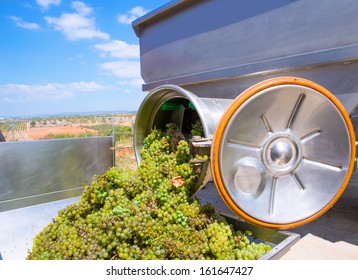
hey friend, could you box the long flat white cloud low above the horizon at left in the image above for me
[0,82,112,102]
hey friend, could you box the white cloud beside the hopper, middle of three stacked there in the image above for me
[94,40,139,59]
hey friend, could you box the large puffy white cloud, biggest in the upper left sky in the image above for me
[45,1,109,40]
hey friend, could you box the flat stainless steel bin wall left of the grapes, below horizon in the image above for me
[0,137,114,212]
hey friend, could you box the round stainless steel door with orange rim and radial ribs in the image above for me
[211,77,355,229]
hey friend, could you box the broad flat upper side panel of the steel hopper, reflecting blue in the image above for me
[134,0,358,89]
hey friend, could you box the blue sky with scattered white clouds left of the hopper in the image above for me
[0,0,169,117]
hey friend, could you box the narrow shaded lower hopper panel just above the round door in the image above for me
[182,60,358,114]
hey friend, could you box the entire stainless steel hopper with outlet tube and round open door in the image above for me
[133,0,358,229]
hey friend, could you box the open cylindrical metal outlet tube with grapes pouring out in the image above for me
[134,85,232,193]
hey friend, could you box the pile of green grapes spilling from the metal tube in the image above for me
[27,123,271,260]
